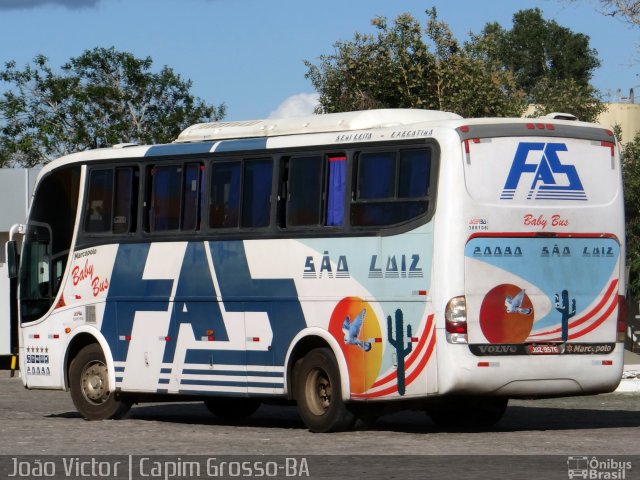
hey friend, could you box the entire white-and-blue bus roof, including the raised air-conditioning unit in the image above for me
[38,109,615,182]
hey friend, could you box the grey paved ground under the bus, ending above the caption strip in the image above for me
[0,374,640,458]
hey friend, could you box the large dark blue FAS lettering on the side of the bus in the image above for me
[101,241,306,379]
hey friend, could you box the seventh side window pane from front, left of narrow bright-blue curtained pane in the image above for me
[287,156,323,227]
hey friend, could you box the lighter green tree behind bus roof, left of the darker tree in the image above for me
[305,9,525,116]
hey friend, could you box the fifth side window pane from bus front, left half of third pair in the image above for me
[209,161,240,228]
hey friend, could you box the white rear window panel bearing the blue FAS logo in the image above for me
[462,136,619,207]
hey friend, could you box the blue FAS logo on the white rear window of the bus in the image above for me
[500,142,587,200]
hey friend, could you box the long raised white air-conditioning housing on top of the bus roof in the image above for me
[174,109,462,143]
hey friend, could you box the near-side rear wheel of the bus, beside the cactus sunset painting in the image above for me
[294,348,355,432]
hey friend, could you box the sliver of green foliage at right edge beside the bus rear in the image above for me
[622,134,640,301]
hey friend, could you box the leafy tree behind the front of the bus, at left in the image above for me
[0,47,225,166]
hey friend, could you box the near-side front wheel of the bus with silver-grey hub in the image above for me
[69,343,131,420]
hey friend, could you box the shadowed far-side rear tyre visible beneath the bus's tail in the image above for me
[427,397,509,429]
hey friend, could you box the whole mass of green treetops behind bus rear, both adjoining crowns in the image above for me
[305,9,602,120]
